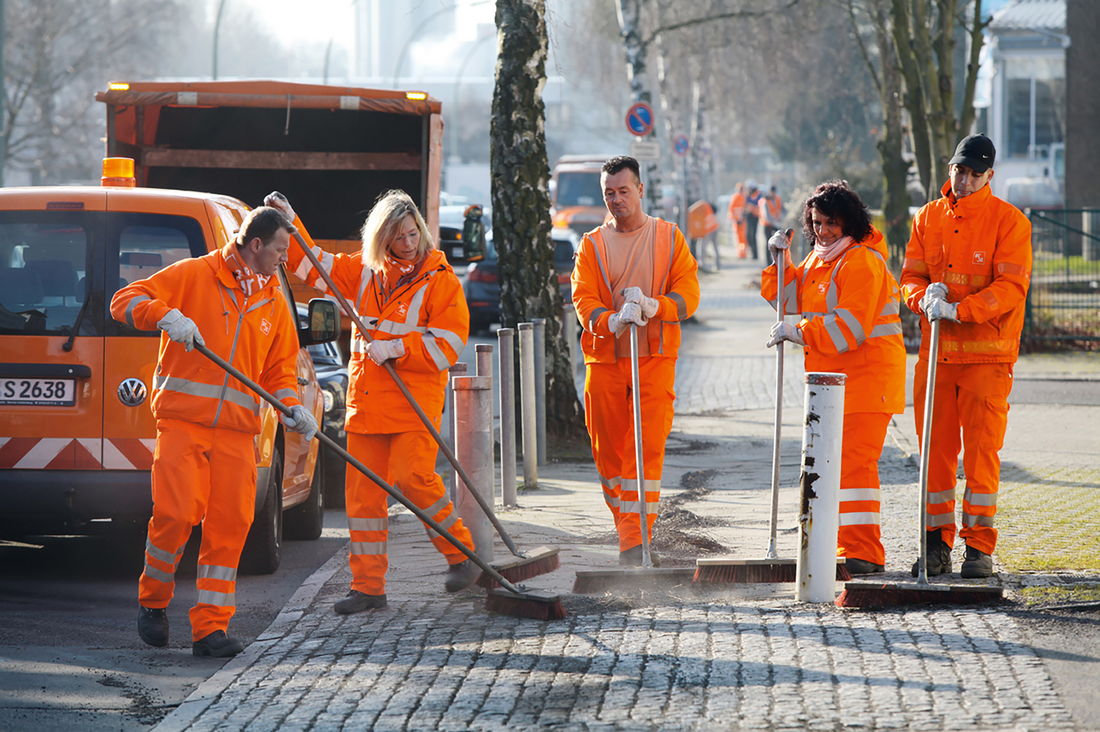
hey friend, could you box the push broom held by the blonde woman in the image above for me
[279,210,561,587]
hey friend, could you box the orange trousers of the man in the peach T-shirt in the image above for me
[584,357,677,551]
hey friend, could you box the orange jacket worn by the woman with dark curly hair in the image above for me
[760,229,905,414]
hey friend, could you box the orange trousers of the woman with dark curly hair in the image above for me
[836,412,890,565]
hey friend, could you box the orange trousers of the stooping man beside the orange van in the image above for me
[138,419,256,641]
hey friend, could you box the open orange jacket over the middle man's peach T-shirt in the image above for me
[573,219,699,363]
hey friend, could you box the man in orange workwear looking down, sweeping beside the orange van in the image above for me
[111,207,317,657]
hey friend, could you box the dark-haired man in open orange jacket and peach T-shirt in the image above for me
[573,155,699,565]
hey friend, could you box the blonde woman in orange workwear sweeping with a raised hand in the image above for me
[265,190,481,615]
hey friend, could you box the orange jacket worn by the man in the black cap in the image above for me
[901,183,1032,363]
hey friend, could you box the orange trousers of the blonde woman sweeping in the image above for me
[344,429,474,594]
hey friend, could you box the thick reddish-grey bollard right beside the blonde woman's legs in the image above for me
[452,376,493,561]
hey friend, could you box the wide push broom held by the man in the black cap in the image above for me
[836,319,1003,608]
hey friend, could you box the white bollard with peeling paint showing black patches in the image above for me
[795,373,847,602]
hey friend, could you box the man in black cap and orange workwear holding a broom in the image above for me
[901,134,1032,577]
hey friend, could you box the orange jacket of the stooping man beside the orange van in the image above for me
[111,243,299,434]
